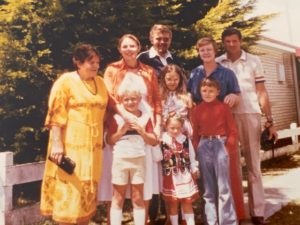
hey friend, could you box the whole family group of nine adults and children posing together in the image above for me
[41,24,277,225]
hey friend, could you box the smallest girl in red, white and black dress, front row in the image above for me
[161,113,199,225]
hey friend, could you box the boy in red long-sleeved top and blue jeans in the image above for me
[192,78,237,225]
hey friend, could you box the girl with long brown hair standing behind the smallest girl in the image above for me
[160,64,192,137]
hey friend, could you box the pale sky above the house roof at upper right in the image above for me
[254,0,300,47]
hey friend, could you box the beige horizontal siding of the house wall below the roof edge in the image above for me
[257,45,298,130]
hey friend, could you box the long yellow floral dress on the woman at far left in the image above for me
[41,72,108,223]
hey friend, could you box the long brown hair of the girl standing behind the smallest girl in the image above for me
[159,64,186,100]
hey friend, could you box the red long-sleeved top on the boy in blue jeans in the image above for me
[191,99,238,151]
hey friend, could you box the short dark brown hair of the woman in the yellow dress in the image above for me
[72,44,100,68]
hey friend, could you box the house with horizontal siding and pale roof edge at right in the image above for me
[256,37,300,130]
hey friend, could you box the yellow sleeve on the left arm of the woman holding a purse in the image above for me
[45,75,70,128]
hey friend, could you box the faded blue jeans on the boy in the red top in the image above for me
[197,138,237,225]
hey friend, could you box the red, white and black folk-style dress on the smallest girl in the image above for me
[161,133,199,202]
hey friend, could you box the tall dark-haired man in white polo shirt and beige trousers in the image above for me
[216,28,277,225]
